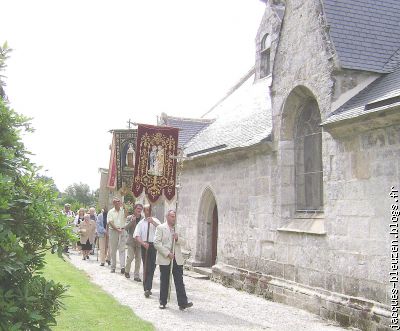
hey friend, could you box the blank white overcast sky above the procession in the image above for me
[0,0,265,190]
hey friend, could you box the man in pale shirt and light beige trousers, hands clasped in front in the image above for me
[107,197,126,274]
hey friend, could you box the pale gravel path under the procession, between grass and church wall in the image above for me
[65,252,356,331]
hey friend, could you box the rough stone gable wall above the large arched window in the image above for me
[271,0,336,124]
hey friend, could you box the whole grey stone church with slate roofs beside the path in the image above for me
[159,0,400,330]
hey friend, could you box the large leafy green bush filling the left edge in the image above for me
[0,46,73,331]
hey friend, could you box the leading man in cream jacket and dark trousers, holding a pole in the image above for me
[154,210,193,310]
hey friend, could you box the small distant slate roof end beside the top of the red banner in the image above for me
[159,113,213,146]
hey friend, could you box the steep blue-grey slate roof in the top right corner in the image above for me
[323,0,400,73]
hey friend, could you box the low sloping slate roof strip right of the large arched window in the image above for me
[322,66,400,124]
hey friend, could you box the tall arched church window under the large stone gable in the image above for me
[294,101,323,212]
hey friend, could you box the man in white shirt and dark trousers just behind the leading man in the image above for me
[133,205,161,298]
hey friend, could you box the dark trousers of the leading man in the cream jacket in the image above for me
[160,259,187,306]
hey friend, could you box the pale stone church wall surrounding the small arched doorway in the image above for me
[179,143,273,269]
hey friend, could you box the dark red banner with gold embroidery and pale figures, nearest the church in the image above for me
[132,124,179,202]
